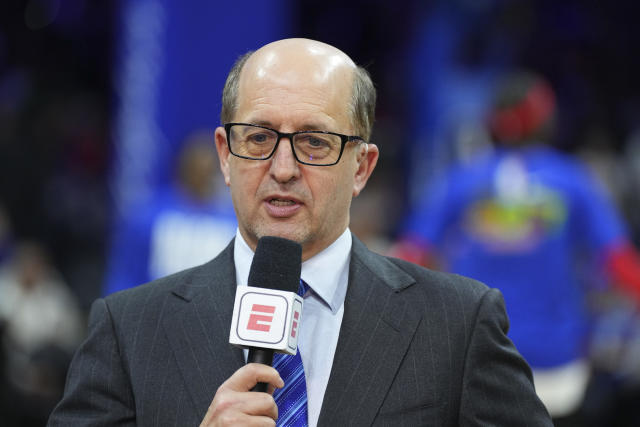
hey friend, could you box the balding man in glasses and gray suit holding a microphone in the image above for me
[50,39,550,426]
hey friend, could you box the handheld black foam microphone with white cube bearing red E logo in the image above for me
[229,236,303,391]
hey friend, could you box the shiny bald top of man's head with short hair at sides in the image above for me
[220,39,376,140]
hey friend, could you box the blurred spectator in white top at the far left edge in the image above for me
[0,242,84,426]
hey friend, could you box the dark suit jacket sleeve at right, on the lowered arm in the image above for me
[459,289,553,427]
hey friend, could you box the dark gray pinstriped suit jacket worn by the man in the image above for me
[49,236,552,426]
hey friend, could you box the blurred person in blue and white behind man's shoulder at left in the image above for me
[105,132,236,294]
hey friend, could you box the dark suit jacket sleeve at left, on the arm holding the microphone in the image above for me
[47,299,136,427]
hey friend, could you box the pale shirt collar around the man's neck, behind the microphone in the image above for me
[233,228,352,313]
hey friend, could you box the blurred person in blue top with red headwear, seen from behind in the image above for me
[393,72,640,425]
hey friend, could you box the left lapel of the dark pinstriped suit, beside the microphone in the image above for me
[163,241,244,415]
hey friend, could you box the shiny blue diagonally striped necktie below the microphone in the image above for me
[273,280,309,427]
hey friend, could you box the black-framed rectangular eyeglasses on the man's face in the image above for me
[224,123,365,166]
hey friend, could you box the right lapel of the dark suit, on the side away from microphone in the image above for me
[318,236,421,425]
